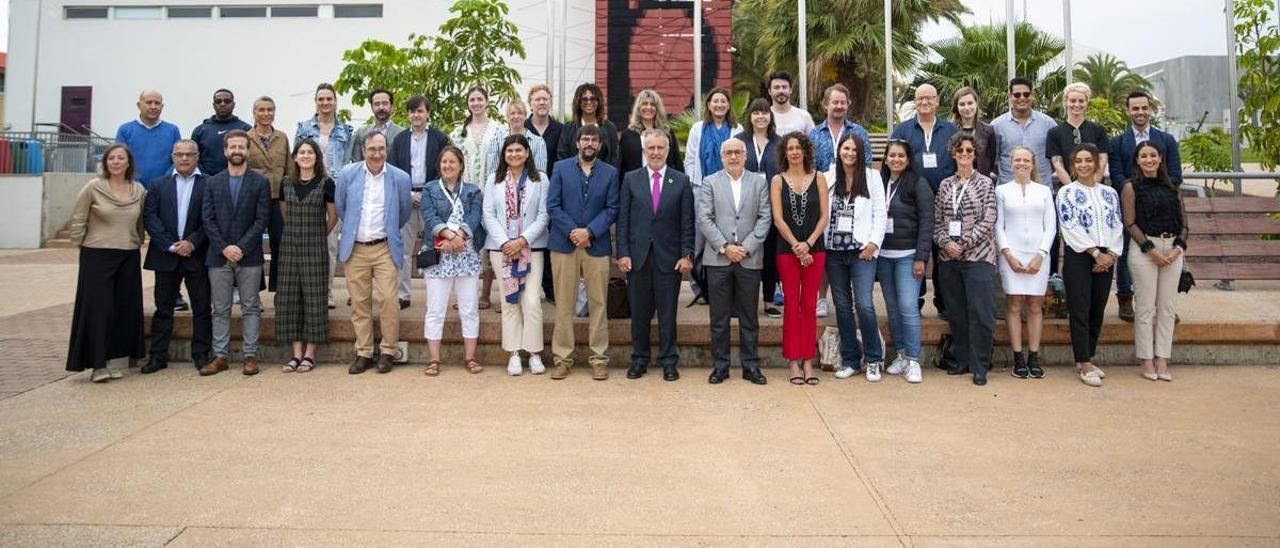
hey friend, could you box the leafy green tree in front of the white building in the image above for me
[334,0,525,127]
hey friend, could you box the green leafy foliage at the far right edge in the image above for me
[1235,0,1280,175]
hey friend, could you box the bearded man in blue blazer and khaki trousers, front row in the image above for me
[547,125,618,380]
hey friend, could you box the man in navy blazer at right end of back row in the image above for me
[1107,91,1183,321]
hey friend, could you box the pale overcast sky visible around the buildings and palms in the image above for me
[0,0,1259,67]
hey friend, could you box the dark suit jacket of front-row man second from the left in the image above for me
[142,173,209,273]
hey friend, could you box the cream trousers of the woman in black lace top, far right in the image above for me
[1129,236,1183,360]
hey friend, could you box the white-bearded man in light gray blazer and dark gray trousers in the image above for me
[698,138,773,384]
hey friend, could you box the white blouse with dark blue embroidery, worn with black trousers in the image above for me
[1057,181,1124,255]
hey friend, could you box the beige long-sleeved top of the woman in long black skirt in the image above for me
[68,178,147,250]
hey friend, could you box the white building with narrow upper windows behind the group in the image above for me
[4,0,595,138]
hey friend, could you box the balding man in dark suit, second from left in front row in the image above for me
[142,140,212,374]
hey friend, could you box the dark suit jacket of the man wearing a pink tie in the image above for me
[618,165,694,273]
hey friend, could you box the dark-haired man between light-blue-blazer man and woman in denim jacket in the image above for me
[386,95,449,310]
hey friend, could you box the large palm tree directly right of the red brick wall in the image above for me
[733,0,968,120]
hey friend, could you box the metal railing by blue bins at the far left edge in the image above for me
[0,131,115,173]
